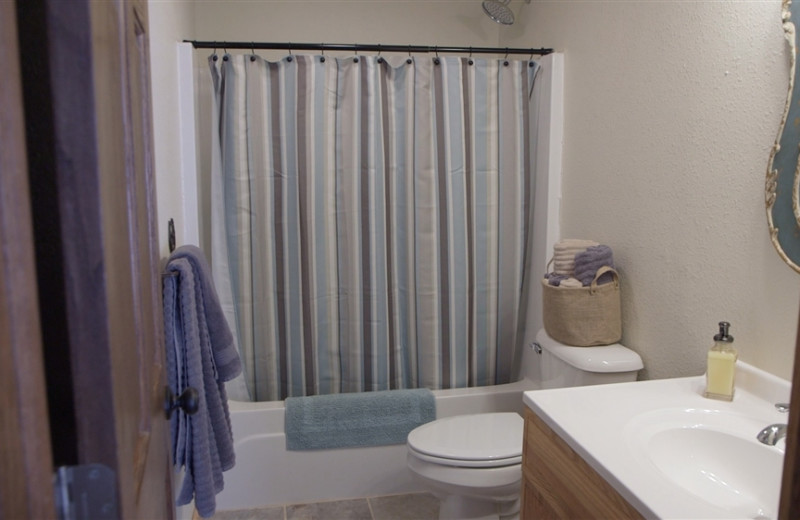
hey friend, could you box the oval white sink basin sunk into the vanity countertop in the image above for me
[625,409,785,519]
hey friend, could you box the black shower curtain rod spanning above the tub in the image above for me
[184,40,553,56]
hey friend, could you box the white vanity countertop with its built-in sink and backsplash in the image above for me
[524,362,791,519]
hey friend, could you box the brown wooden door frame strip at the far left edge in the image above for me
[0,2,55,519]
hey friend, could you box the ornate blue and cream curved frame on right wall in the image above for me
[765,0,800,273]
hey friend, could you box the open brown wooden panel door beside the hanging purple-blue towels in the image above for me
[17,0,174,519]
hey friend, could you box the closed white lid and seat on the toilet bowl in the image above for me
[408,413,524,466]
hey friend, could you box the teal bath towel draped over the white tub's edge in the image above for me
[285,388,436,450]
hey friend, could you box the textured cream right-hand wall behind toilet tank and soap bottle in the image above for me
[500,0,800,379]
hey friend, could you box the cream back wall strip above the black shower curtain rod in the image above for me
[191,0,499,58]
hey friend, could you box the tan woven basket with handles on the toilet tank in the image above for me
[542,266,622,347]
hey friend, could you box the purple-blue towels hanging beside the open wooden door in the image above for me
[164,246,242,518]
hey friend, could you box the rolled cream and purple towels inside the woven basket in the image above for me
[545,238,614,287]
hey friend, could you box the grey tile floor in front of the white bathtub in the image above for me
[206,493,439,520]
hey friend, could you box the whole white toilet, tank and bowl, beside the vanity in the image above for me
[406,330,644,520]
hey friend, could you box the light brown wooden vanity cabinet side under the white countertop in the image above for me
[521,408,644,520]
